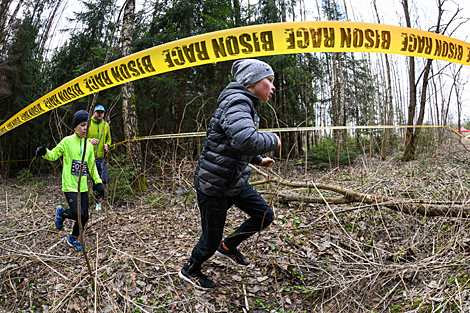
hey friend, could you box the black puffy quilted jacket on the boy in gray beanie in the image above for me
[194,82,278,197]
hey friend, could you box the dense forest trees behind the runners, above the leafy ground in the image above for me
[0,0,468,177]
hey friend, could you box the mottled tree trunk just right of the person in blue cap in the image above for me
[122,0,147,191]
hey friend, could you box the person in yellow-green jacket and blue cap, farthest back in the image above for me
[88,104,111,211]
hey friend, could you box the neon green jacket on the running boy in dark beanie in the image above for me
[43,134,102,192]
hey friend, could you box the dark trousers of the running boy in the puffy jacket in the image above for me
[190,184,274,269]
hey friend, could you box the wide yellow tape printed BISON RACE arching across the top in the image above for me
[0,21,470,136]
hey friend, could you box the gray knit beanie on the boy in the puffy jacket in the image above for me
[232,59,274,87]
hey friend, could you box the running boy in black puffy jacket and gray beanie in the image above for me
[179,59,281,289]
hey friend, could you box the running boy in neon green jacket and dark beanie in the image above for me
[36,110,104,250]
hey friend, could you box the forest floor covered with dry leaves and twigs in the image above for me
[0,135,470,313]
